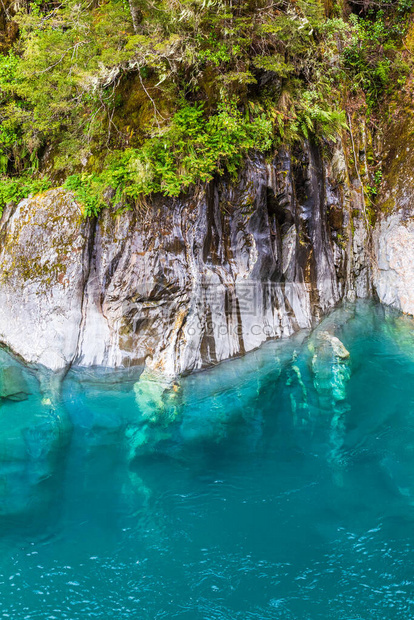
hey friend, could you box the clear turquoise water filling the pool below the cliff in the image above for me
[0,304,414,620]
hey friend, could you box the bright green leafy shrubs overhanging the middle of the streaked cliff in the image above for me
[65,102,272,215]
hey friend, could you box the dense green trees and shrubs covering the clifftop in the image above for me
[0,0,414,214]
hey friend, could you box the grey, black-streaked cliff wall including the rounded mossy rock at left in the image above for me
[0,145,371,376]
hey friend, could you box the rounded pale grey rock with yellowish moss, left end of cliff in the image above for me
[0,190,90,370]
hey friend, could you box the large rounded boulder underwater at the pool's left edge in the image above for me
[0,355,71,517]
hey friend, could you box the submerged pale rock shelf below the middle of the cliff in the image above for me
[125,332,306,460]
